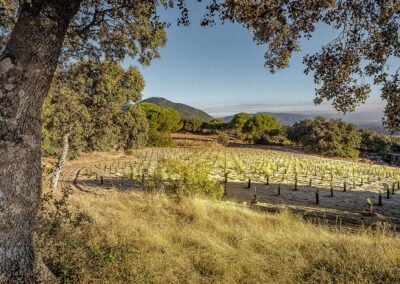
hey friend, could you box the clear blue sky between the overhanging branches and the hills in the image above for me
[125,1,383,117]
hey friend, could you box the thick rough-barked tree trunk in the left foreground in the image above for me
[0,0,80,283]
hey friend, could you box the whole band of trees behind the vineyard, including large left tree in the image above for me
[42,60,400,173]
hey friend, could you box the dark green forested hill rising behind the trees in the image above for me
[142,97,213,121]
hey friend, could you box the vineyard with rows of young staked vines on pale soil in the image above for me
[50,148,400,229]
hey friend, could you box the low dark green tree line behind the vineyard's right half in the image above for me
[182,112,400,160]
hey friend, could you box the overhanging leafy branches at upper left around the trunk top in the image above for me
[0,0,167,65]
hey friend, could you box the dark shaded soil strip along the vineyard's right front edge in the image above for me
[226,182,400,230]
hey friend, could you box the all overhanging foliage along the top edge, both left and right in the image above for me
[0,0,400,130]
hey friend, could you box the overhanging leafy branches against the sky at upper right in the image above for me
[203,0,400,130]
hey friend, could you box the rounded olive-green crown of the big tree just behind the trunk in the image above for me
[42,61,148,154]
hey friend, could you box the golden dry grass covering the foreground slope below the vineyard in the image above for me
[42,187,400,283]
